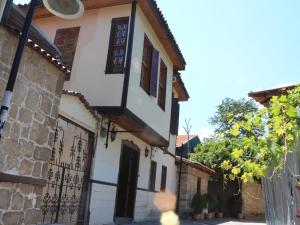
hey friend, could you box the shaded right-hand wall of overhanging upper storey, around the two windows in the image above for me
[127,7,173,140]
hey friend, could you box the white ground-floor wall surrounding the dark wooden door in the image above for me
[90,124,177,225]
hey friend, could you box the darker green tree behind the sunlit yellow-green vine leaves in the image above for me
[190,98,258,175]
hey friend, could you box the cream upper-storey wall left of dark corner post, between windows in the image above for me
[35,4,131,106]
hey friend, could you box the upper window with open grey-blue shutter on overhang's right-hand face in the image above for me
[140,35,159,97]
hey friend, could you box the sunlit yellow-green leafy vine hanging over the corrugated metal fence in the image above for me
[219,86,300,182]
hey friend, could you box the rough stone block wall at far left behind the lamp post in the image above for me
[0,26,64,225]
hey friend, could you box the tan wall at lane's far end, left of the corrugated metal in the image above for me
[242,183,265,217]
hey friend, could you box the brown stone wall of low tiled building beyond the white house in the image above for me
[178,164,209,214]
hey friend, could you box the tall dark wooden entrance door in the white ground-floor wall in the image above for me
[115,145,140,222]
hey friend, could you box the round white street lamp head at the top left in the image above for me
[43,0,84,19]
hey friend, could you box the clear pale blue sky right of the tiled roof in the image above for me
[15,0,300,136]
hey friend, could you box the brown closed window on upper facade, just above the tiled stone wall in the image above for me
[54,27,80,80]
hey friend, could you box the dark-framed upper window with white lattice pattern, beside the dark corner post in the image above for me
[105,17,129,74]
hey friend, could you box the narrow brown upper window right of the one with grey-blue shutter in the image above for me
[158,60,168,110]
